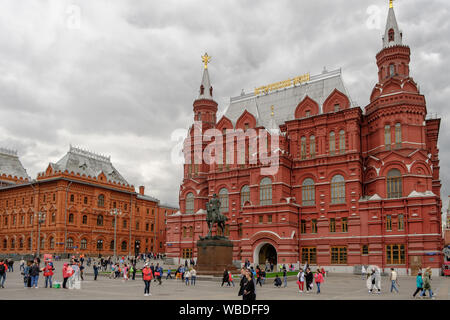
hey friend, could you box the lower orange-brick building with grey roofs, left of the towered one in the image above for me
[0,146,178,256]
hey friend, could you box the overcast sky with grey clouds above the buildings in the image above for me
[0,0,450,212]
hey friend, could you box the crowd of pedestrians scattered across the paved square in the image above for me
[0,254,435,300]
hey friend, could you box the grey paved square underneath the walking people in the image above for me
[0,262,450,300]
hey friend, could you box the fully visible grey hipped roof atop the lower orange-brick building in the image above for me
[50,146,129,185]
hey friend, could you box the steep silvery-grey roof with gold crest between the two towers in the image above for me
[225,69,354,129]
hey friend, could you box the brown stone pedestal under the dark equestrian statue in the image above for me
[196,237,239,276]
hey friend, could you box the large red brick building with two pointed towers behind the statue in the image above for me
[166,4,443,274]
